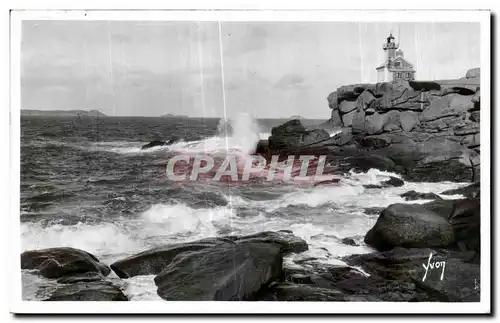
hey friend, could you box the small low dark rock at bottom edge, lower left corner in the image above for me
[46,281,128,301]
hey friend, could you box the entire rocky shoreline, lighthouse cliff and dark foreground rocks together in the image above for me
[21,69,481,302]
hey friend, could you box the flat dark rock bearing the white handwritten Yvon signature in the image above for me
[344,248,480,302]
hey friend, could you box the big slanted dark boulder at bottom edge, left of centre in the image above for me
[154,242,283,301]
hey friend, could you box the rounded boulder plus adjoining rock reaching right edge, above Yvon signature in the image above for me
[365,190,481,259]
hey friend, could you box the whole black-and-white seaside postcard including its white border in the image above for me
[10,6,491,313]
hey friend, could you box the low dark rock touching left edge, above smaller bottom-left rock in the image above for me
[21,247,110,278]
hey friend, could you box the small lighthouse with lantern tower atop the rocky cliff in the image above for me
[376,34,416,82]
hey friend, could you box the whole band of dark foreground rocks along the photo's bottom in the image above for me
[21,184,480,302]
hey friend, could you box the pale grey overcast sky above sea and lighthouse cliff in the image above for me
[21,21,480,119]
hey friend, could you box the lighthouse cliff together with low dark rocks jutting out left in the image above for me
[246,69,480,182]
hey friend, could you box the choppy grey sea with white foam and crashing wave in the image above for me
[20,114,466,301]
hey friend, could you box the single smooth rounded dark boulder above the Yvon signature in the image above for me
[365,204,455,250]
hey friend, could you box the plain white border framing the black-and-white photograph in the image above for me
[8,8,491,314]
